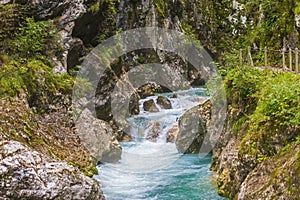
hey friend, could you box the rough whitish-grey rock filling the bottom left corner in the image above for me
[0,141,105,200]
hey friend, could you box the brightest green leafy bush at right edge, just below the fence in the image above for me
[251,72,300,128]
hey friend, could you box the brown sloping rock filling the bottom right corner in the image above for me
[237,144,300,200]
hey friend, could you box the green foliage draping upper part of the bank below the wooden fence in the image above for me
[225,67,300,163]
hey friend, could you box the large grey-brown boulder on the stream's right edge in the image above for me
[175,101,211,153]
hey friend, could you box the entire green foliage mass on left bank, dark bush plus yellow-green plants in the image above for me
[0,14,74,109]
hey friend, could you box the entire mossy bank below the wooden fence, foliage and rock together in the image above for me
[211,67,300,199]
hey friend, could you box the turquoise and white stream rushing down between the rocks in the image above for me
[95,89,227,200]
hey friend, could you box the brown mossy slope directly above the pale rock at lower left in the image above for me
[0,95,96,176]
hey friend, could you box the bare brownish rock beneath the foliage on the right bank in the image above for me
[211,110,300,200]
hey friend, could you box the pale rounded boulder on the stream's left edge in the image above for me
[76,109,122,163]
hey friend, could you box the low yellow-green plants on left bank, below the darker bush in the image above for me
[0,59,74,98]
